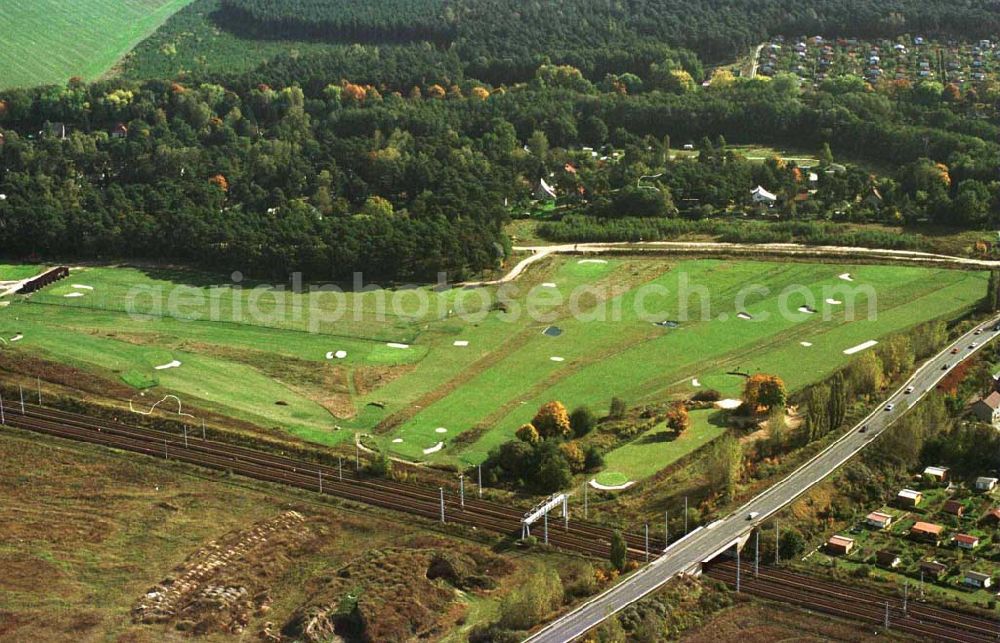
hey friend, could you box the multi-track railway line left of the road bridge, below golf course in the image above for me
[4,404,664,561]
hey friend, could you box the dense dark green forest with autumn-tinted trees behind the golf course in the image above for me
[0,0,1000,280]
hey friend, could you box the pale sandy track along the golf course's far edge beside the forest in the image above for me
[488,241,1000,286]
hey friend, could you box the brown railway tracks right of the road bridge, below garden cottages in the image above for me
[705,560,1000,643]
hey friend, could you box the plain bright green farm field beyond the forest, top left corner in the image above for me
[0,0,191,89]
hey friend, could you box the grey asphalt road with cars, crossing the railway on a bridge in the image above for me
[526,317,1000,643]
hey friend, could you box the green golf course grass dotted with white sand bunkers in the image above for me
[0,257,986,468]
